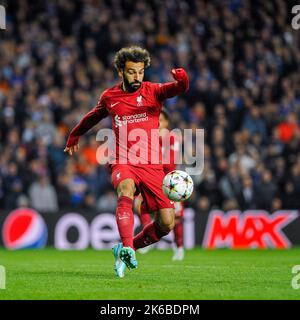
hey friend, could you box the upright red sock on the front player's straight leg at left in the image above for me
[116,196,134,248]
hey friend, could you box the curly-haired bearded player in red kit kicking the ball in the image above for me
[64,46,189,277]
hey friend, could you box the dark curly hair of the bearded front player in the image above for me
[114,46,150,70]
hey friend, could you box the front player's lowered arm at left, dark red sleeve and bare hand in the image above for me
[64,103,108,156]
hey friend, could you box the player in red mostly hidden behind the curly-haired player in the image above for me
[137,108,184,261]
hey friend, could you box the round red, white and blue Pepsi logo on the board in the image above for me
[2,208,48,249]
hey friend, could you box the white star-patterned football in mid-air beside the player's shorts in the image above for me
[162,170,194,202]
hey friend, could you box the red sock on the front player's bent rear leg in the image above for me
[133,221,169,250]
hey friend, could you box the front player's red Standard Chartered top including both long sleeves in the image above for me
[67,75,189,166]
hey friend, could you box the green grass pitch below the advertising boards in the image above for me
[0,248,300,300]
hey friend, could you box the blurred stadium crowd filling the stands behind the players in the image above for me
[0,0,300,212]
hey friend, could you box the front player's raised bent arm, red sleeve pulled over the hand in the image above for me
[157,68,189,100]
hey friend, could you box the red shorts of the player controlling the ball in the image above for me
[111,164,174,212]
